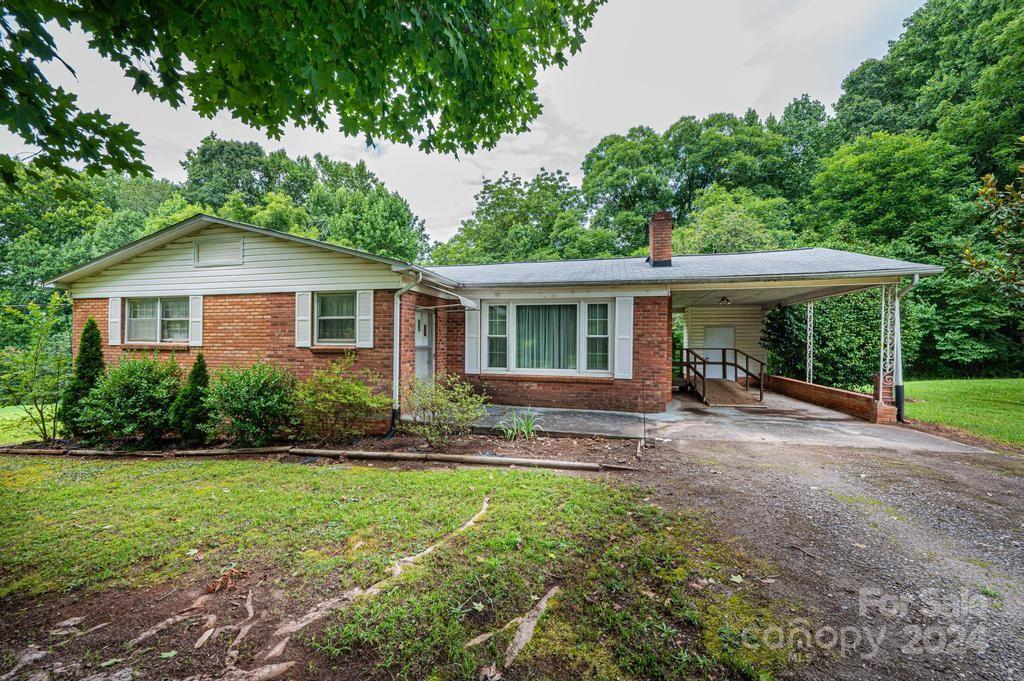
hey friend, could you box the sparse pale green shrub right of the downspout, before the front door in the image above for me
[406,374,487,450]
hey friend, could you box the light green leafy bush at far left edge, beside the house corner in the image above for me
[0,293,71,441]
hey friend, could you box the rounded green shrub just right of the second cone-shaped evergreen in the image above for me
[206,364,295,446]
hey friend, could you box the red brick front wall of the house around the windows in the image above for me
[73,291,672,412]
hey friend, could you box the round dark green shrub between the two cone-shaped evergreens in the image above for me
[79,356,181,449]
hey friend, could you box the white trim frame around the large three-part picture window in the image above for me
[480,298,615,378]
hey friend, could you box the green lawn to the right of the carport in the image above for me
[906,378,1024,445]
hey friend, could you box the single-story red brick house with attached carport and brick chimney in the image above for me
[47,212,942,420]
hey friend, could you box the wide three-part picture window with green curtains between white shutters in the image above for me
[480,300,613,375]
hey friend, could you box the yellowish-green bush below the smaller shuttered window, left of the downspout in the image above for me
[296,354,391,442]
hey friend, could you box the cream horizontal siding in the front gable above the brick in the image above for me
[71,226,401,298]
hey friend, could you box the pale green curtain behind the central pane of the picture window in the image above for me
[515,305,577,369]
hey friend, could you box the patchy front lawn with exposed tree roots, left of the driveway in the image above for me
[0,457,792,679]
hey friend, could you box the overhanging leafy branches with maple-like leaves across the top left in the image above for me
[0,0,604,182]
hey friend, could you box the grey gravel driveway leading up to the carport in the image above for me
[632,396,1024,679]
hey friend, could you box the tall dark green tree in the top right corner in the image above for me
[836,0,1024,181]
